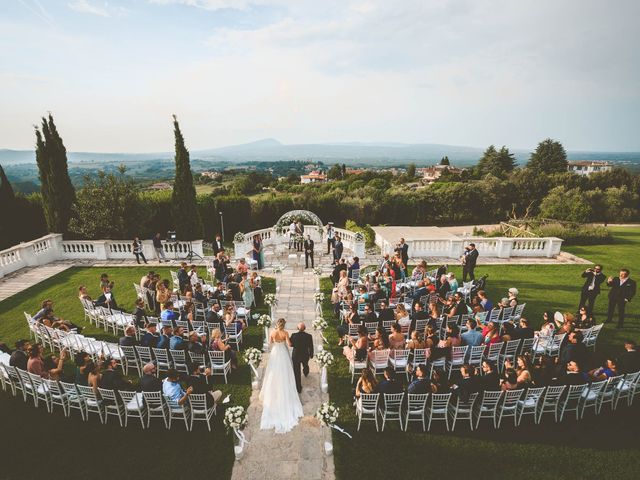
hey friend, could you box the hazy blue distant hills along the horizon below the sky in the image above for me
[0,138,640,167]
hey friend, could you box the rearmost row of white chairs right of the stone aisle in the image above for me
[356,372,640,431]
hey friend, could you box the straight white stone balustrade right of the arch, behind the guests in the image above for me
[376,235,562,258]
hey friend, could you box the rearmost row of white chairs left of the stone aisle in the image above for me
[0,363,216,431]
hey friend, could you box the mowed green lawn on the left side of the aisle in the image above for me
[0,267,275,479]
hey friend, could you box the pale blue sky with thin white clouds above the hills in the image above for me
[0,0,640,152]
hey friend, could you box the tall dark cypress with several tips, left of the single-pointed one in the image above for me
[36,114,75,233]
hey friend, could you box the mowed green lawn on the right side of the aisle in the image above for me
[321,228,640,479]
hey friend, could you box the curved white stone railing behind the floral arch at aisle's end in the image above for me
[233,225,365,258]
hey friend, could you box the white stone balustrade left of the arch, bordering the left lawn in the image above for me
[0,233,203,277]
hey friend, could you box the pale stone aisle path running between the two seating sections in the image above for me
[232,267,335,480]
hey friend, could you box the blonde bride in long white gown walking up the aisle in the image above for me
[260,318,303,433]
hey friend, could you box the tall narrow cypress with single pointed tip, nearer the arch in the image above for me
[171,115,204,240]
